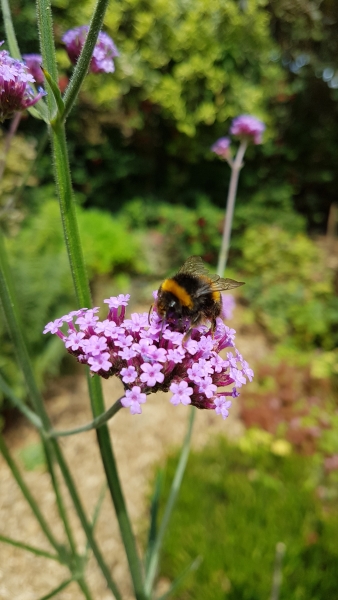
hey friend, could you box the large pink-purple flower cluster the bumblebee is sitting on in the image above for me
[44,294,253,419]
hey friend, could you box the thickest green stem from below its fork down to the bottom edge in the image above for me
[51,122,145,600]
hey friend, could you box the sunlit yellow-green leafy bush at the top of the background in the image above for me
[57,0,282,135]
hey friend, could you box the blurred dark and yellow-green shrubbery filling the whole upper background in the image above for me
[1,0,338,231]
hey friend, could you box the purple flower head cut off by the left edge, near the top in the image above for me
[0,42,46,121]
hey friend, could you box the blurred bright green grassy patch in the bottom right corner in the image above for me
[160,432,338,600]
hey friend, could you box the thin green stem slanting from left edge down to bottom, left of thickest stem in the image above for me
[0,235,121,600]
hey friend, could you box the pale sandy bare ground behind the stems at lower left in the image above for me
[0,309,268,600]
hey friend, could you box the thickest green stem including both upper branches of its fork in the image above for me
[37,0,145,600]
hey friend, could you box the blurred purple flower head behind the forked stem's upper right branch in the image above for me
[62,25,119,73]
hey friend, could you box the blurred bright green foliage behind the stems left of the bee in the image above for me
[0,200,146,404]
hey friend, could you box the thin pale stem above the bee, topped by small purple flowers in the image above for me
[217,140,248,277]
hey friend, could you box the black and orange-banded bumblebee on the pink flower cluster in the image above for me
[149,256,244,341]
